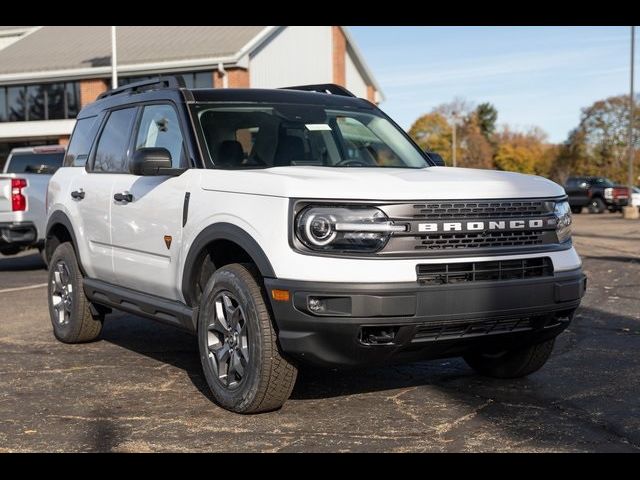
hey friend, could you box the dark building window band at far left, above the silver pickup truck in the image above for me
[0,82,80,122]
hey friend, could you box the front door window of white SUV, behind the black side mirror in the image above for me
[136,105,188,168]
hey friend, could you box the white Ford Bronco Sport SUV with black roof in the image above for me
[46,78,586,413]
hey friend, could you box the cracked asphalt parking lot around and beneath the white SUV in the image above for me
[0,214,640,452]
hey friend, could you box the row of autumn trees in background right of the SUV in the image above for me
[409,95,640,183]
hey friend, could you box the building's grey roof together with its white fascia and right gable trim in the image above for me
[0,26,383,98]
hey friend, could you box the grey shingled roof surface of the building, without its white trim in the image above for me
[0,26,266,75]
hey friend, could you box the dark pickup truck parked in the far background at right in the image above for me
[564,177,629,213]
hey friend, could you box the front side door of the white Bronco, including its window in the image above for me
[111,103,189,300]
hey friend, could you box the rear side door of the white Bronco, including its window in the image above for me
[69,107,138,283]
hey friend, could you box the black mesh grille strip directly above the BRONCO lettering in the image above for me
[413,200,554,220]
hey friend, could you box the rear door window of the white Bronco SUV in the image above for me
[93,108,137,173]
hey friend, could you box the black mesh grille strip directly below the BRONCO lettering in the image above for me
[414,230,544,250]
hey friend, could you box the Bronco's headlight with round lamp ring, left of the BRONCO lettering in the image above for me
[295,206,407,252]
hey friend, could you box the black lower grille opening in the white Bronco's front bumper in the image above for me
[416,257,553,285]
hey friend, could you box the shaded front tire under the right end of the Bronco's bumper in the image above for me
[464,338,555,378]
